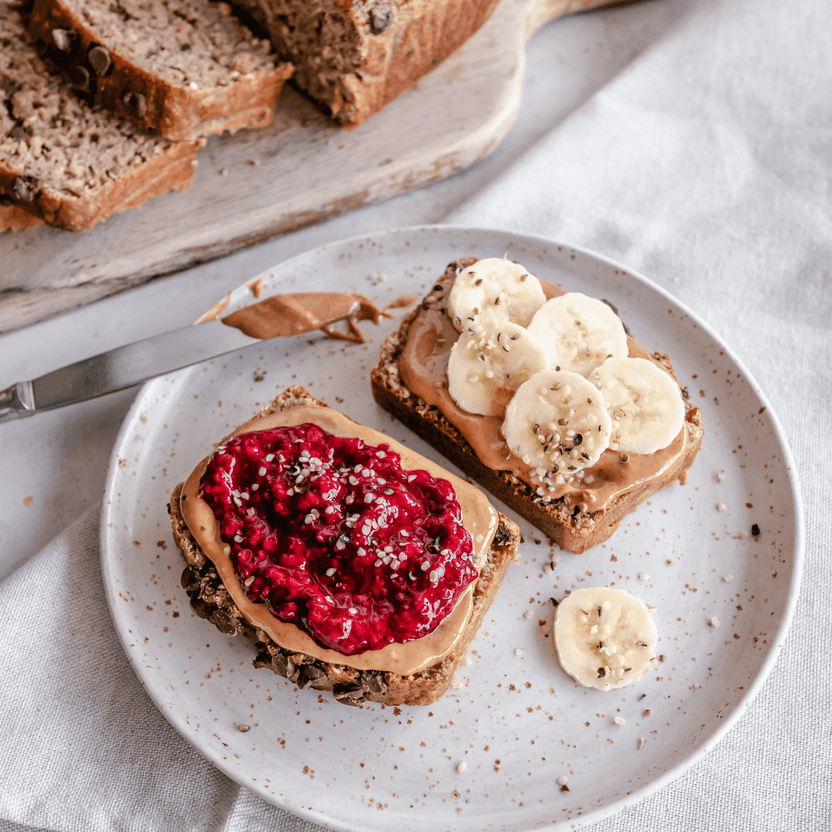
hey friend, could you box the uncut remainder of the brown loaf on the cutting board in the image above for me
[221,0,497,127]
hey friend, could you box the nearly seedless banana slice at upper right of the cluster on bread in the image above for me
[529,292,628,376]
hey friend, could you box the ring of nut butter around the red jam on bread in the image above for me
[181,405,498,676]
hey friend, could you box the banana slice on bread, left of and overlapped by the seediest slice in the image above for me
[448,321,552,418]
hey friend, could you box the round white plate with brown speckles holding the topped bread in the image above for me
[101,227,802,832]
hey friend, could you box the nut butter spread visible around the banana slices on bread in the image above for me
[399,281,688,512]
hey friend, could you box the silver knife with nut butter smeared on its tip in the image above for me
[0,292,381,422]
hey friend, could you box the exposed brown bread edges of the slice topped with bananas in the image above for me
[371,257,702,553]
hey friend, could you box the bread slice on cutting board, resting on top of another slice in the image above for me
[28,0,292,141]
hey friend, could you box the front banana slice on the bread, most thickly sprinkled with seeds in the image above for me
[503,370,612,480]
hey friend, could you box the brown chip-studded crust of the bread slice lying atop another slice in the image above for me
[28,0,293,141]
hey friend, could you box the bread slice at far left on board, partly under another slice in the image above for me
[0,3,200,231]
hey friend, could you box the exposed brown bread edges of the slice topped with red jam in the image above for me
[169,386,520,705]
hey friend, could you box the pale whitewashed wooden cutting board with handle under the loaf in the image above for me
[0,0,636,332]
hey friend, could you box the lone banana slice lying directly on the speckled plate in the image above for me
[552,587,658,690]
